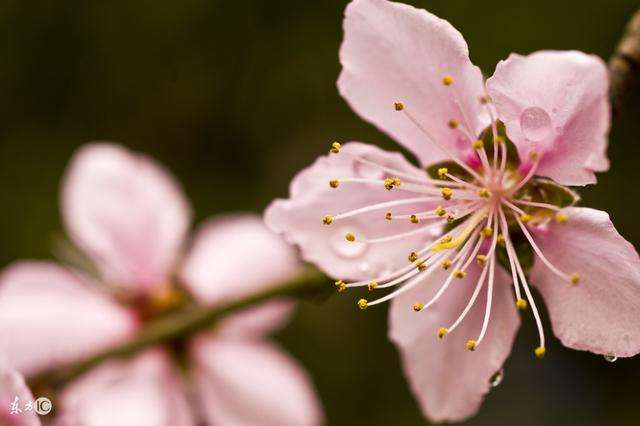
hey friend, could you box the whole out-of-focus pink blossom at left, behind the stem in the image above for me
[0,144,321,425]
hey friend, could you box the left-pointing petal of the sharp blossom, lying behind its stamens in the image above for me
[265,142,435,279]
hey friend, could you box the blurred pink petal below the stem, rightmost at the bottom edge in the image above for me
[193,338,322,426]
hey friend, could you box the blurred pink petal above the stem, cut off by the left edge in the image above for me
[0,262,137,375]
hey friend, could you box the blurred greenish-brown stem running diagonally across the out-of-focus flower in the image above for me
[30,268,329,387]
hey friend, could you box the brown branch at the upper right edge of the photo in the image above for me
[609,10,640,115]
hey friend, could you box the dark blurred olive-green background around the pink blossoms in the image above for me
[0,0,640,425]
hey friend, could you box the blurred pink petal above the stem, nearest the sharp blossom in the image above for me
[182,214,301,304]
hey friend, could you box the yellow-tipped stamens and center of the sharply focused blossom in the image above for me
[322,76,579,357]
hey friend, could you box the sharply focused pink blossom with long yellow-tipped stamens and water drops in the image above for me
[265,0,640,421]
